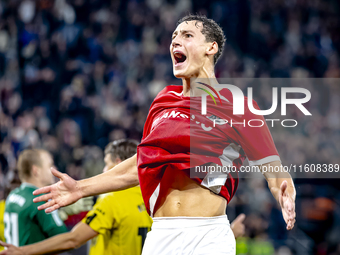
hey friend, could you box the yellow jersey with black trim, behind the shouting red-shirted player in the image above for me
[83,187,152,255]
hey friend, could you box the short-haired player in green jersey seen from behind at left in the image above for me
[4,149,67,246]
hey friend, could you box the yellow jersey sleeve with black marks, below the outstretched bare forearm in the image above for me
[82,194,114,234]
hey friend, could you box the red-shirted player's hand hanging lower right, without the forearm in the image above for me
[279,181,296,230]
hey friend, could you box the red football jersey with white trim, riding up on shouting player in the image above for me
[137,85,280,216]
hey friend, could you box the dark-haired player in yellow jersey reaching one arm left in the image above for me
[0,139,152,255]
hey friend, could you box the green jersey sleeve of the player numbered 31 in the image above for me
[31,203,67,237]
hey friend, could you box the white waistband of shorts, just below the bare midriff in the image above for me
[152,215,230,229]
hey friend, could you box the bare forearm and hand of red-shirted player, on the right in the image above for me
[259,161,296,230]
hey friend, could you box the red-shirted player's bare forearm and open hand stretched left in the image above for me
[33,154,139,213]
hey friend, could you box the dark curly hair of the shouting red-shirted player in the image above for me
[177,14,226,64]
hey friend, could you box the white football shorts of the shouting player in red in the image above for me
[142,215,236,255]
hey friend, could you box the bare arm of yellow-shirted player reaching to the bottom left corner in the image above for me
[0,222,98,255]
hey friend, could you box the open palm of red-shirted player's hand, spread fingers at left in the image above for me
[33,168,82,213]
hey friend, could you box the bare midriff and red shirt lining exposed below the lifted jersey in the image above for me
[154,167,227,217]
